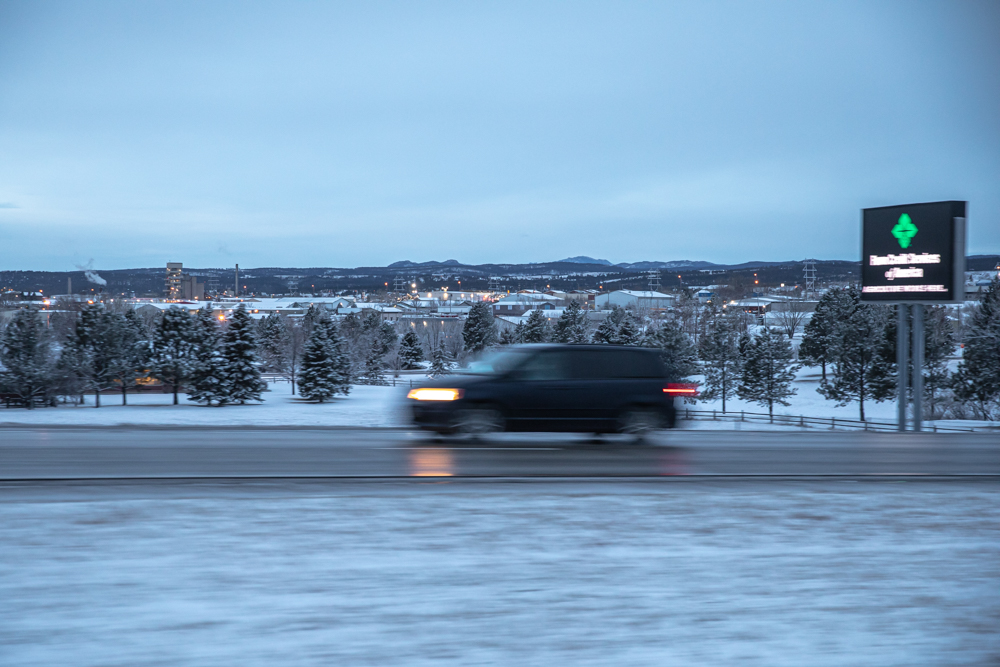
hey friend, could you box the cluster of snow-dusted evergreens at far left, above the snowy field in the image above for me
[0,304,266,407]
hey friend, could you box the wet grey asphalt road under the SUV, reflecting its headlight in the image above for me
[0,428,1000,481]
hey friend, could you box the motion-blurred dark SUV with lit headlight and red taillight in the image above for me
[407,345,693,435]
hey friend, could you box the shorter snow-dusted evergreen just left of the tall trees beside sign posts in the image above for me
[736,327,796,417]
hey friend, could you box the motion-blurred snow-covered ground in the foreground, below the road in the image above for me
[0,481,1000,667]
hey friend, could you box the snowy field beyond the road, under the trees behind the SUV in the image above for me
[0,369,990,430]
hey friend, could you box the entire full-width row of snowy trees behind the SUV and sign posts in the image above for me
[0,281,1000,419]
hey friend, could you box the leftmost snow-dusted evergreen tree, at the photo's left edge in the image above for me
[0,308,56,408]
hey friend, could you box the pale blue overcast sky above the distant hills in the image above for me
[0,0,1000,271]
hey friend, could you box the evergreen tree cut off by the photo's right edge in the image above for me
[953,278,1000,419]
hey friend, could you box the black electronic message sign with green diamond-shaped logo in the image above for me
[861,201,966,303]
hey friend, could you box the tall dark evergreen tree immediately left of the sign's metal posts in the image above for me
[818,287,896,421]
